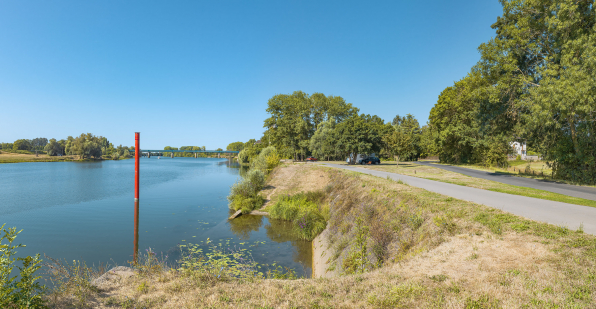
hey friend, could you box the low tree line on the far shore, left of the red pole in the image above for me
[0,133,134,159]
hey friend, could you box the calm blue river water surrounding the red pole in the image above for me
[0,157,312,276]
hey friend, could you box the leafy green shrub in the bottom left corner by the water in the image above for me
[0,224,45,308]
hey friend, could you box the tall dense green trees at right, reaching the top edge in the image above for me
[429,0,596,184]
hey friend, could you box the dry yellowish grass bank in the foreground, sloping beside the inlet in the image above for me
[48,164,596,308]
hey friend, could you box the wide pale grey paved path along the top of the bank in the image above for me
[322,163,596,235]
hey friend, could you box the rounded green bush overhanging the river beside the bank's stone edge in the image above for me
[228,169,265,213]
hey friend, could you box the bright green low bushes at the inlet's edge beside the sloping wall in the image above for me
[268,191,329,241]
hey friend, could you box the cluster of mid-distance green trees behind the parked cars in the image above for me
[226,91,436,162]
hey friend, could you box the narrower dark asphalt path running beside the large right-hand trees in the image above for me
[414,161,596,201]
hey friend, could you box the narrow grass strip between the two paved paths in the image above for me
[330,161,596,207]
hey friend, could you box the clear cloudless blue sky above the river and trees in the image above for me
[0,0,502,149]
